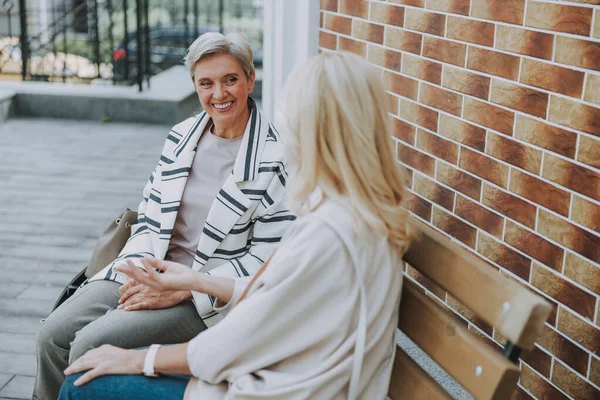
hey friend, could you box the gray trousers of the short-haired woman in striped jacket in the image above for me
[33,281,206,400]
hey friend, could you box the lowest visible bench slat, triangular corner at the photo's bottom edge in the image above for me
[388,347,452,400]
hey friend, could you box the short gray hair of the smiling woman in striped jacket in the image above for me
[183,32,255,79]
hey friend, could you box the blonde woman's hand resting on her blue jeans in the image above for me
[65,344,147,386]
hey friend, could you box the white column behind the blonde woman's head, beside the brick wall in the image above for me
[262,0,320,121]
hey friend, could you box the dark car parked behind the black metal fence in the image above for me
[113,27,263,85]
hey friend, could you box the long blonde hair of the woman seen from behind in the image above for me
[279,52,412,251]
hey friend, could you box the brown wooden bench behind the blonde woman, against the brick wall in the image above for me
[389,222,551,400]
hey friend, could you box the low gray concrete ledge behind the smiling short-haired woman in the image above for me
[0,66,262,125]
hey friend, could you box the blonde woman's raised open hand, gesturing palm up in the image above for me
[115,258,197,292]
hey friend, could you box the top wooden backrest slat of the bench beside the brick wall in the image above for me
[404,221,551,350]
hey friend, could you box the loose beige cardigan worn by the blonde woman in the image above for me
[187,192,402,400]
